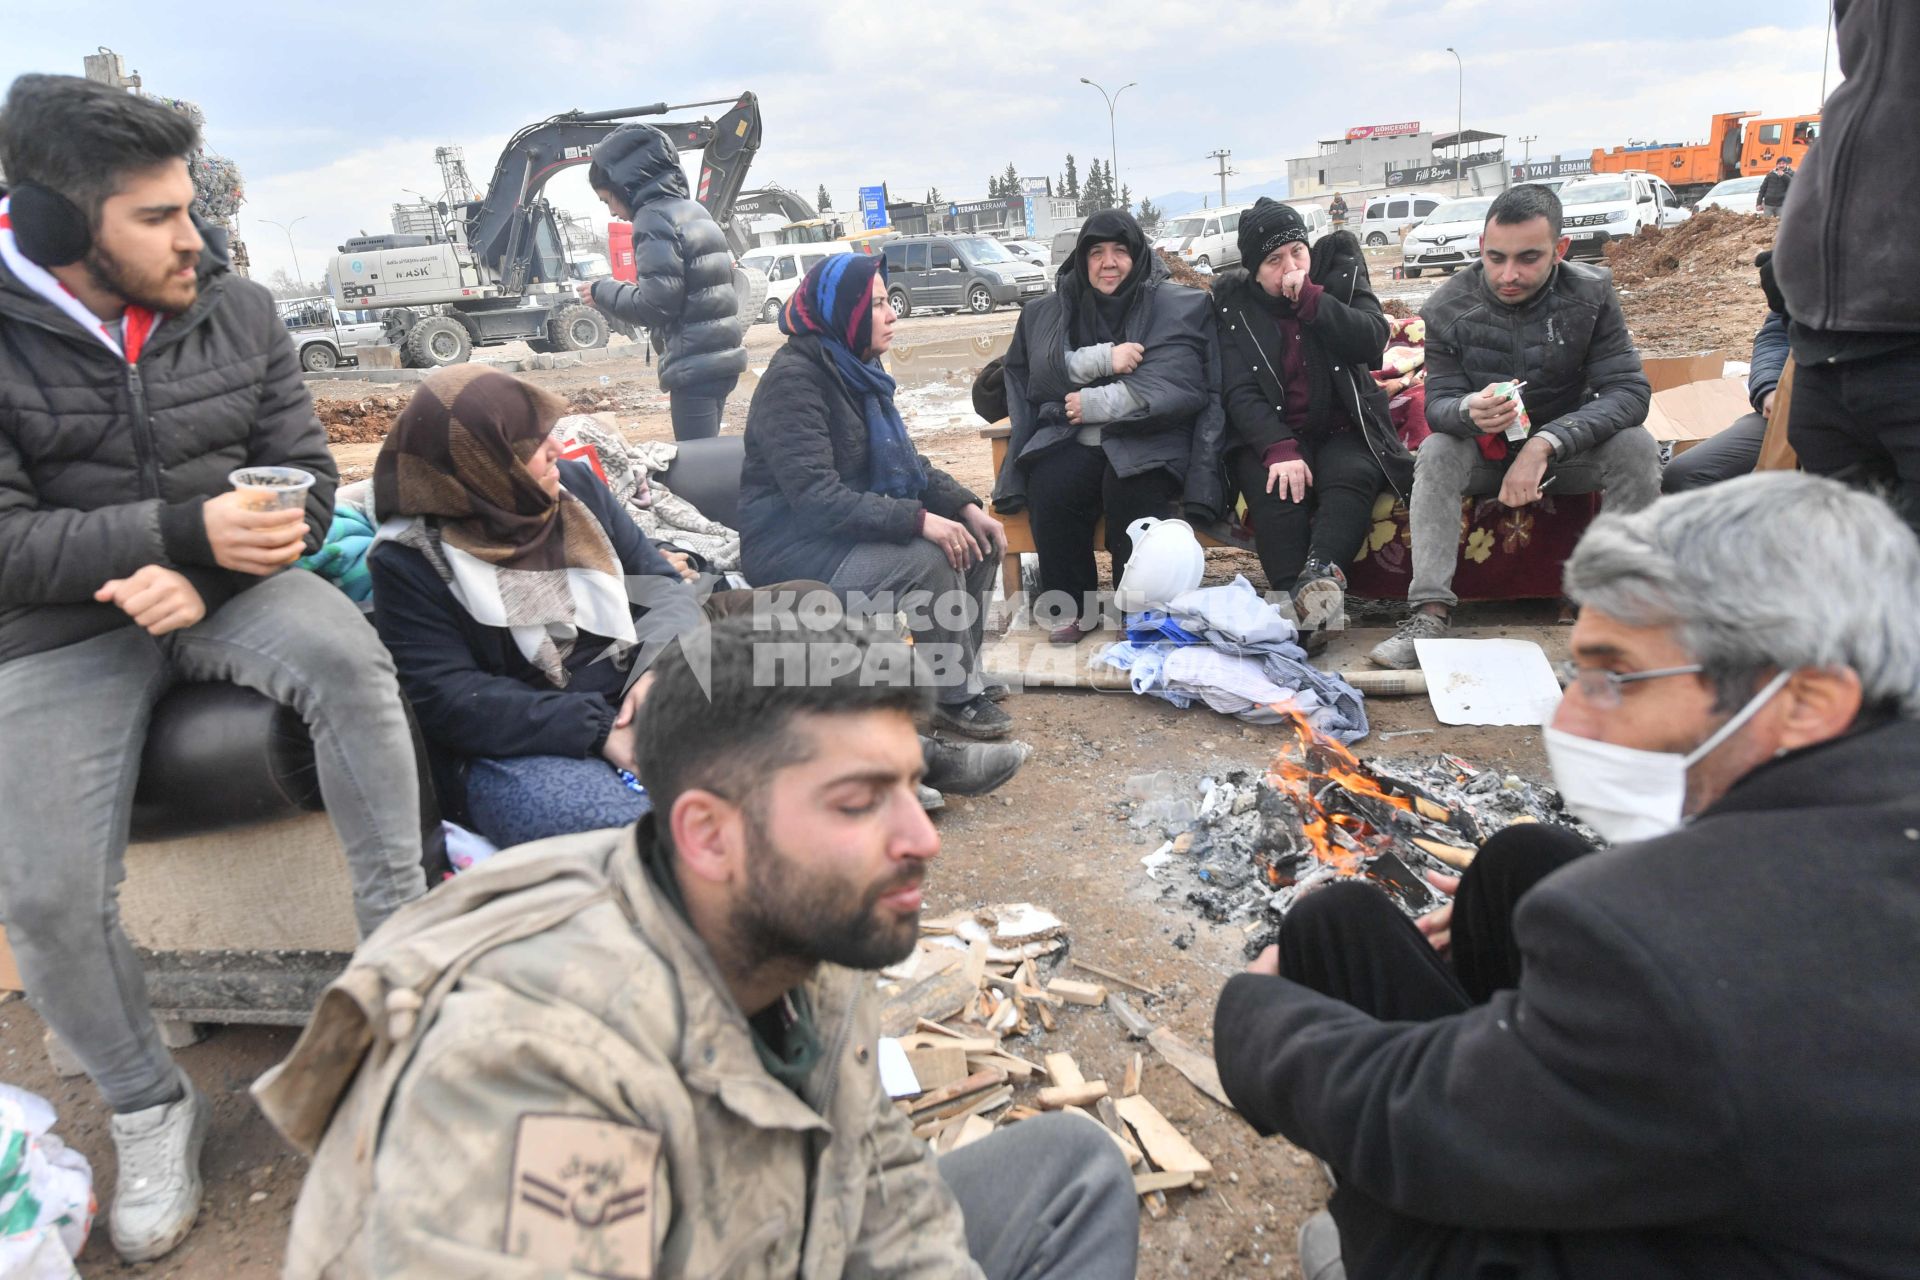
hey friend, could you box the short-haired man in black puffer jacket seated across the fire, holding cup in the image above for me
[1367,184,1661,670]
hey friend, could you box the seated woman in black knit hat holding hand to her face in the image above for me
[1213,198,1413,628]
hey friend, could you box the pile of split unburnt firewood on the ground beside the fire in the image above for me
[879,902,1231,1217]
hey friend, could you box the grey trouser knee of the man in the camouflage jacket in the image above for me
[941,1115,1140,1280]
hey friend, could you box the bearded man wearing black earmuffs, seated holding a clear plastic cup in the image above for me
[0,75,424,1261]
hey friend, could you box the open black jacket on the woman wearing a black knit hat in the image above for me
[1213,230,1413,497]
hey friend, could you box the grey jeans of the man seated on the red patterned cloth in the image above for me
[1407,426,1661,608]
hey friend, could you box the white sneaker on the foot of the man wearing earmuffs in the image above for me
[111,1071,207,1263]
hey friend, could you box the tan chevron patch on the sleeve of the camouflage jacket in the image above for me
[507,1115,660,1280]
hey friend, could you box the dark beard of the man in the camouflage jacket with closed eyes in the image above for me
[732,810,925,969]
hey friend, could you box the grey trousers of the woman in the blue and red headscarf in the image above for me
[828,537,1000,706]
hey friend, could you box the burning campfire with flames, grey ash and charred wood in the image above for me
[1129,722,1599,952]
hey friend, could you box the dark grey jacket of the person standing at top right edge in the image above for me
[1774,0,1920,334]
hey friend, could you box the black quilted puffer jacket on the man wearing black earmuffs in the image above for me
[0,197,338,662]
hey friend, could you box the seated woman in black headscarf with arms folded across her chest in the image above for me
[993,209,1221,645]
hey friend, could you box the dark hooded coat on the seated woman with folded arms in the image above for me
[993,215,1227,524]
